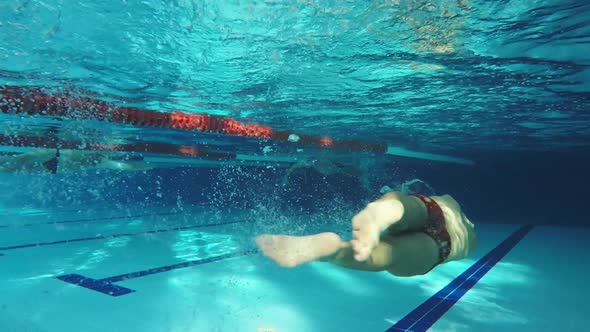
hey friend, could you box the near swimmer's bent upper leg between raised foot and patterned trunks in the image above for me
[377,191,428,233]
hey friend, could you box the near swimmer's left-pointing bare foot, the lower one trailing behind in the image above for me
[256,233,345,267]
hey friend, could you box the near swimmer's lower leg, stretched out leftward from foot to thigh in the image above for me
[256,233,438,276]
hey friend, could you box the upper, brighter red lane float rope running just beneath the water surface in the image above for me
[0,86,473,165]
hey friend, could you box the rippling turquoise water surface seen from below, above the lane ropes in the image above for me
[0,1,590,150]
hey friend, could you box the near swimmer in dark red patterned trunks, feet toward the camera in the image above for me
[256,192,477,277]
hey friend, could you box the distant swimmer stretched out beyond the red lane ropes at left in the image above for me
[0,149,151,174]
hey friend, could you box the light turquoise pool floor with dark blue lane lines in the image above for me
[0,207,590,332]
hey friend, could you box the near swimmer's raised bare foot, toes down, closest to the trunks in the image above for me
[350,195,404,262]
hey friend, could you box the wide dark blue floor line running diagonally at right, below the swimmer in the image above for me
[387,225,533,332]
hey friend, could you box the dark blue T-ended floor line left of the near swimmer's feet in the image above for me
[56,249,258,297]
